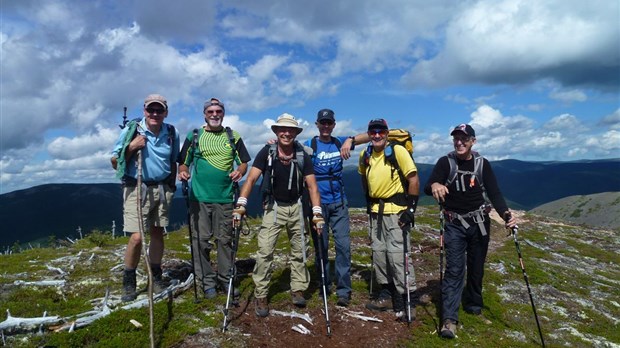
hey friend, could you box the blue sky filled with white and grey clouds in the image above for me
[0,0,620,193]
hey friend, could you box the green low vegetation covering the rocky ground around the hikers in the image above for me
[0,211,620,347]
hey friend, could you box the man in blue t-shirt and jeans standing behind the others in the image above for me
[304,109,355,307]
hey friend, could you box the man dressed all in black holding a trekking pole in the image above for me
[424,124,517,338]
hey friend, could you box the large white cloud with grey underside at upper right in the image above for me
[403,0,620,89]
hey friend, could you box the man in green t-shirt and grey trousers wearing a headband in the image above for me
[179,98,250,299]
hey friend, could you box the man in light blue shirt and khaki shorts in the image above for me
[112,94,179,302]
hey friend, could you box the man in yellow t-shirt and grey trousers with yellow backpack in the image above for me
[358,119,420,321]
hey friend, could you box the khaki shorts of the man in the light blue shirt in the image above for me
[123,184,174,233]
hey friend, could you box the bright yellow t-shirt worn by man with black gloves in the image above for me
[357,146,418,214]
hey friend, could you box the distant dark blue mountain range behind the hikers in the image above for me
[0,159,620,246]
